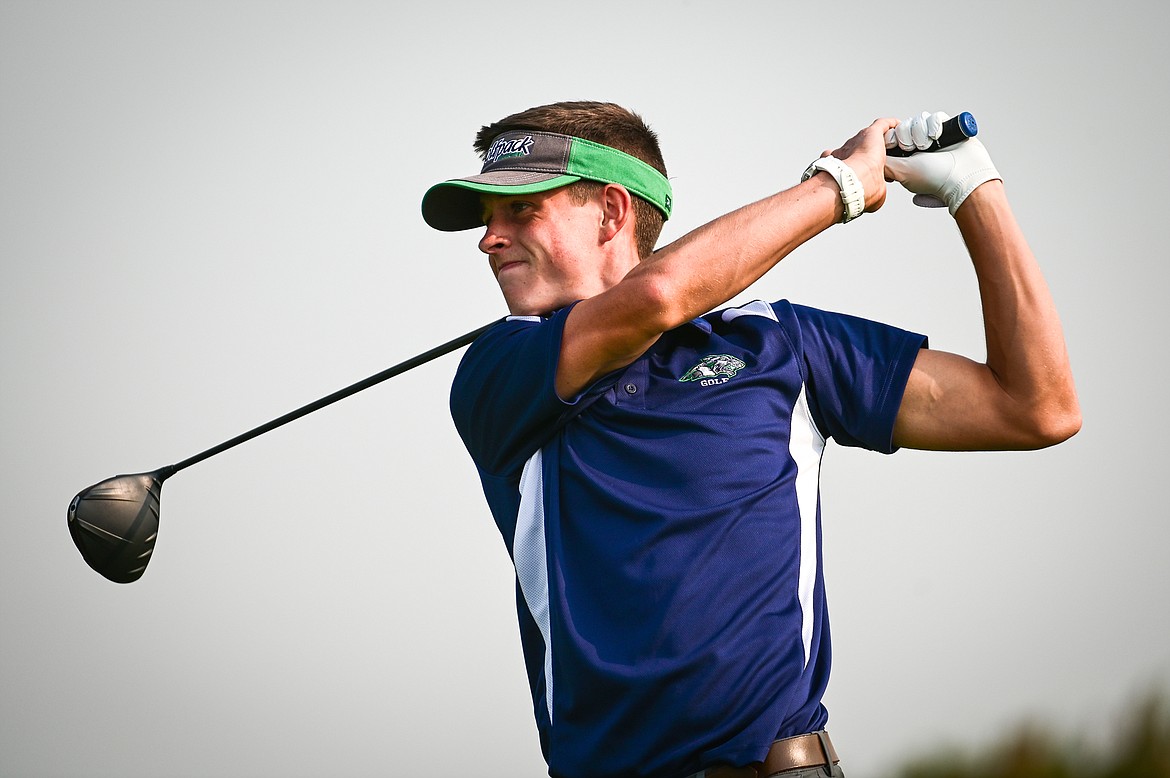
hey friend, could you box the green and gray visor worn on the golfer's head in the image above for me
[422,130,672,232]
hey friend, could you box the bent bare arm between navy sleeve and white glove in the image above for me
[894,179,1081,450]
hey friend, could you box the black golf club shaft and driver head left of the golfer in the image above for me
[68,319,503,584]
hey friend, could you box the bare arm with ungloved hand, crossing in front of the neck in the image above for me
[556,119,897,398]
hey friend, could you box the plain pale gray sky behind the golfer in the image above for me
[0,0,1170,777]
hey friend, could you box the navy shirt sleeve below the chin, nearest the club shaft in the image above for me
[450,309,573,475]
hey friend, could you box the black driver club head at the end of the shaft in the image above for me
[68,471,166,584]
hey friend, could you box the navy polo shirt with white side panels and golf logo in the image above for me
[450,301,925,778]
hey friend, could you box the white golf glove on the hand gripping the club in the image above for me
[886,111,1003,216]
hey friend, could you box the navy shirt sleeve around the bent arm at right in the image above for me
[792,305,928,454]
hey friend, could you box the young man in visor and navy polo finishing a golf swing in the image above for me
[422,103,1080,778]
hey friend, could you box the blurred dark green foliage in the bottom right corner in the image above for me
[893,695,1170,778]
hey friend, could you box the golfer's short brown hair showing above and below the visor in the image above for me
[475,101,667,259]
